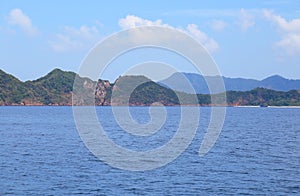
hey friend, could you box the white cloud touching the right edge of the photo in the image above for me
[264,10,300,56]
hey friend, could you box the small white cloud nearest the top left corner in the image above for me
[7,9,38,35]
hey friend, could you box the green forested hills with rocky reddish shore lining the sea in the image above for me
[0,69,300,106]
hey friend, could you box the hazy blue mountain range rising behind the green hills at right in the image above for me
[159,73,300,94]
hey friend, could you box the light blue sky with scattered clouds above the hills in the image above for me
[0,0,300,81]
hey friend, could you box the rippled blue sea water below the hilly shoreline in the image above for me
[0,107,300,195]
